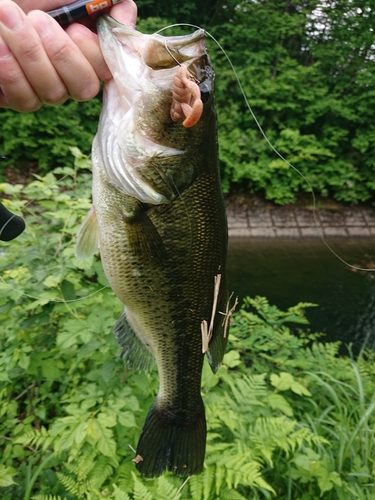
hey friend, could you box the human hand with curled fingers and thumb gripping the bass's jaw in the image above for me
[0,0,137,112]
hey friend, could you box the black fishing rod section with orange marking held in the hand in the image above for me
[47,0,123,26]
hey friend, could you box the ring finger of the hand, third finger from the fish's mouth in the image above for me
[0,0,69,104]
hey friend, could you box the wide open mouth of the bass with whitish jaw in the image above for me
[98,15,212,126]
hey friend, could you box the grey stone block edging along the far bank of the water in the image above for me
[227,206,375,238]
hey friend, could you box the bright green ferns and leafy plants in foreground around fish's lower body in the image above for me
[0,149,375,500]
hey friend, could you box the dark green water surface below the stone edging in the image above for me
[228,238,375,350]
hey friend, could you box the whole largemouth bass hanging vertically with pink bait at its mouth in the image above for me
[76,16,228,477]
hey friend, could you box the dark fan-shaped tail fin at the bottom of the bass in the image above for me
[134,400,206,477]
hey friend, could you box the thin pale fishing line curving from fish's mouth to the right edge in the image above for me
[156,23,375,272]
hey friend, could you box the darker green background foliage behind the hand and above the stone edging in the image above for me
[0,0,375,204]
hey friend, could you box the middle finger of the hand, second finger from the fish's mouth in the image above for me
[28,10,100,101]
